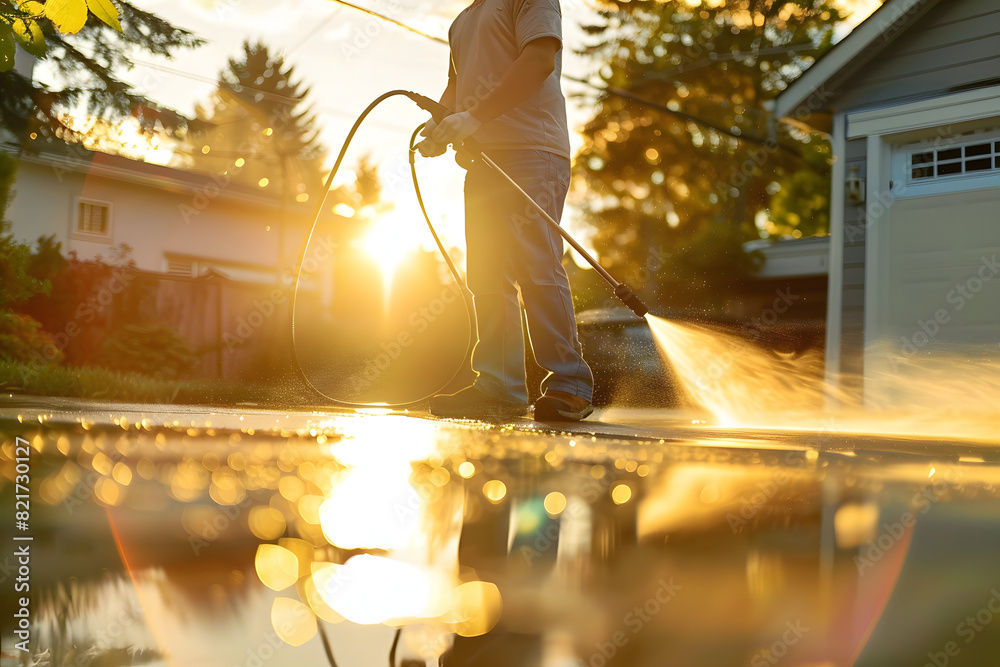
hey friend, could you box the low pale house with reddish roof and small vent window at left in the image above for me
[0,142,311,285]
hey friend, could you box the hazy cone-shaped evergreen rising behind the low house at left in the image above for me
[187,42,324,202]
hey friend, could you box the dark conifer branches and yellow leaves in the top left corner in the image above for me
[0,0,203,140]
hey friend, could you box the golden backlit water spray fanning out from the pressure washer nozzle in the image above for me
[646,315,1000,442]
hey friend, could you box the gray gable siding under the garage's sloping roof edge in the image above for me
[834,0,1000,110]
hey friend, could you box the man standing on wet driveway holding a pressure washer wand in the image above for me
[418,0,594,421]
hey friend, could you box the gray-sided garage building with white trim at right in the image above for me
[776,0,1000,396]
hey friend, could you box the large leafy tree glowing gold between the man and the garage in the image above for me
[576,0,841,306]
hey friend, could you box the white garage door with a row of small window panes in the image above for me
[865,129,1000,396]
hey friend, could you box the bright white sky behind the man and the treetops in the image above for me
[38,0,880,258]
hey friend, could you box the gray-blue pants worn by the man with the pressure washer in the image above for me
[465,150,594,403]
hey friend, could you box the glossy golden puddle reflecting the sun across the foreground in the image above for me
[2,415,1000,667]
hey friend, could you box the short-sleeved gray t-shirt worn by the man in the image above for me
[448,0,570,159]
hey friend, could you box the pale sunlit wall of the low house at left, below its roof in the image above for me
[8,160,311,283]
